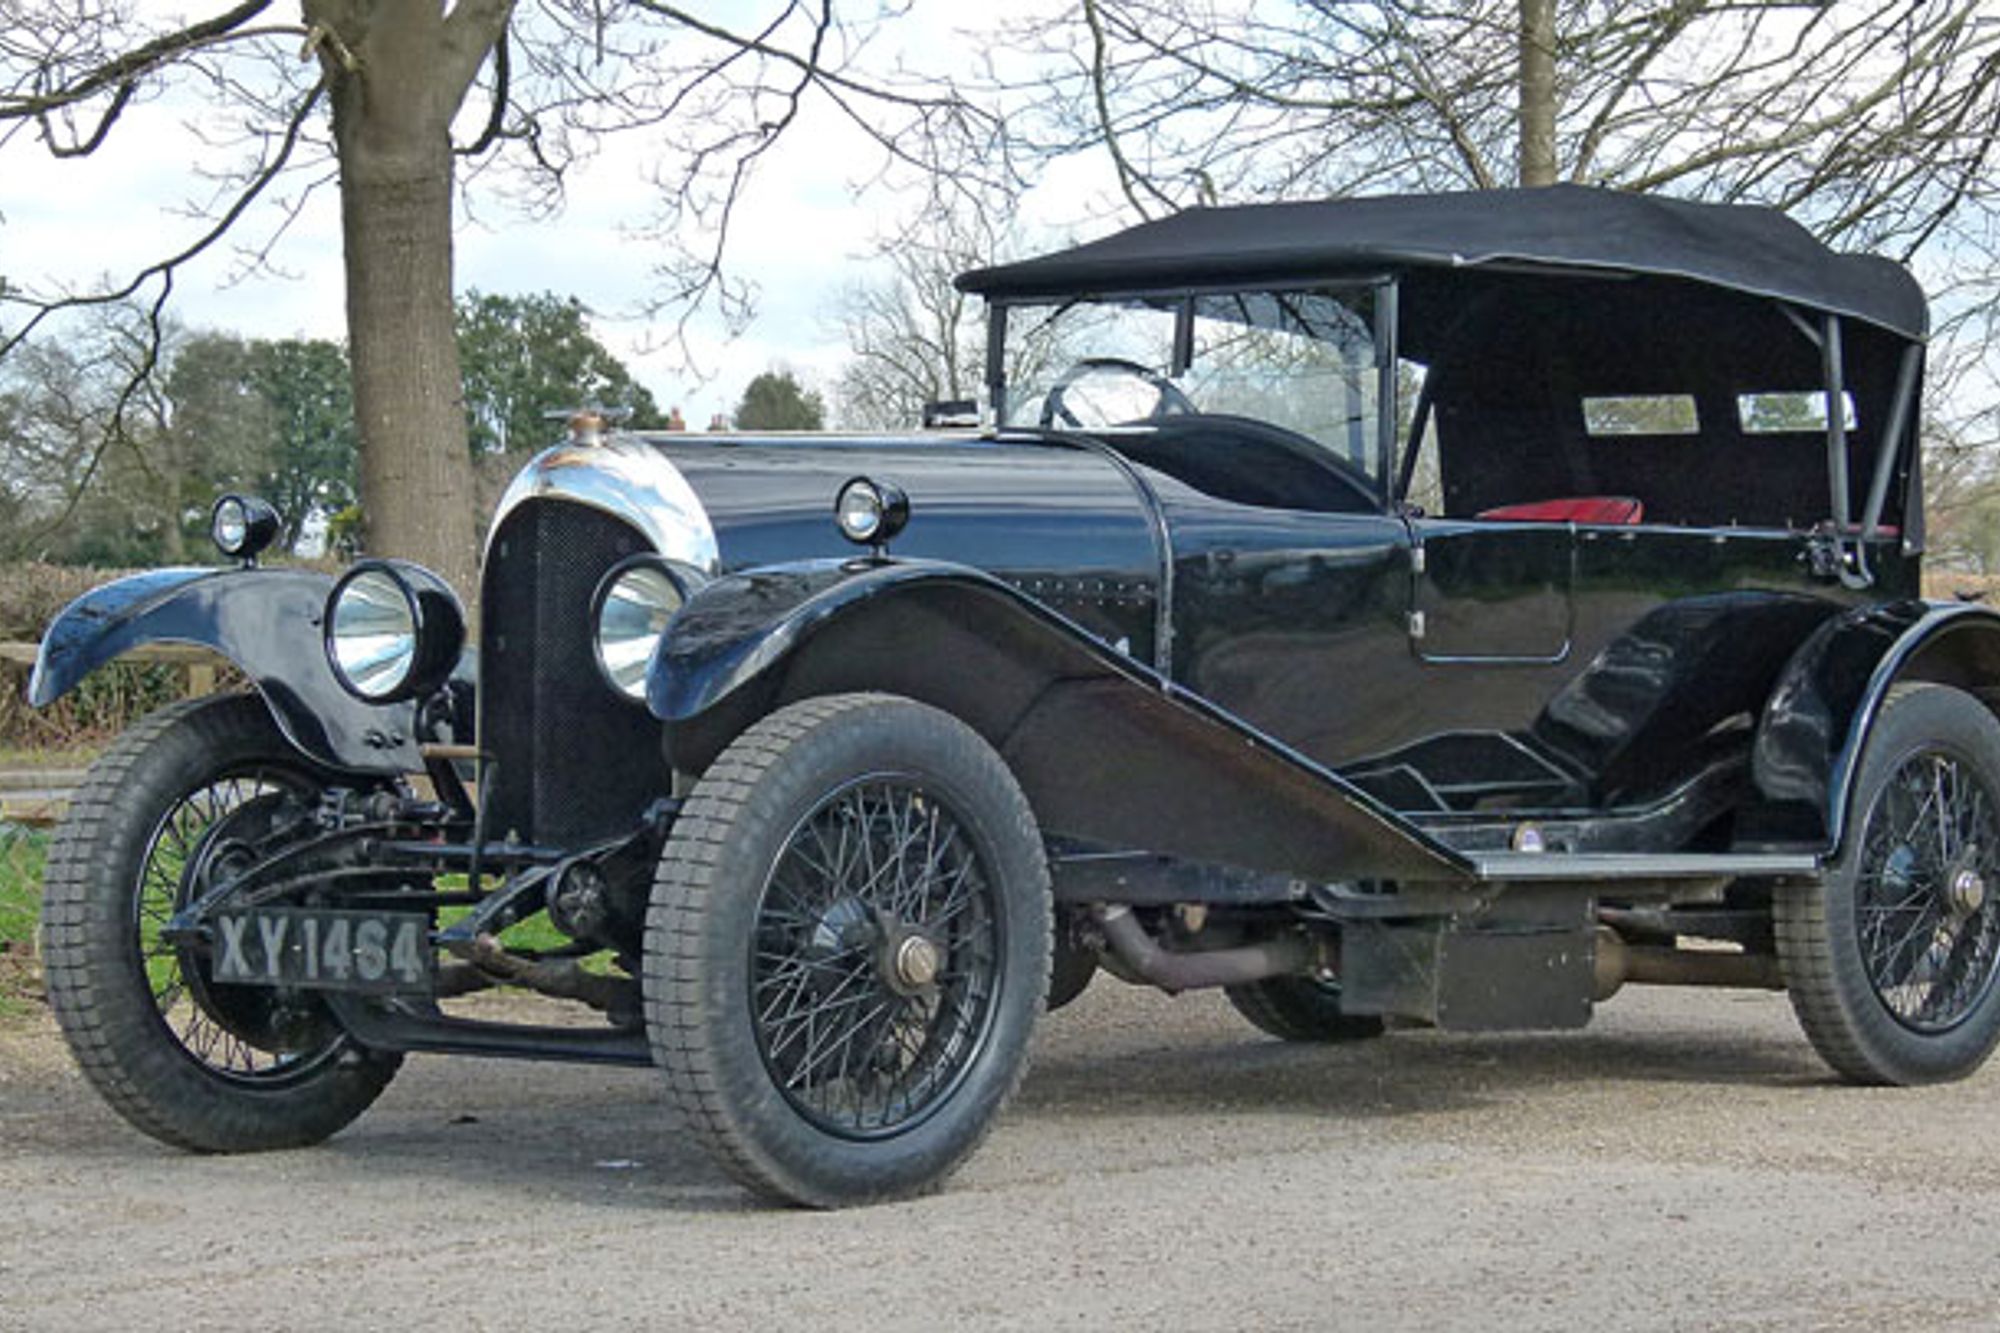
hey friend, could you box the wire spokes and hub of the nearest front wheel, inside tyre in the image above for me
[750,777,1000,1137]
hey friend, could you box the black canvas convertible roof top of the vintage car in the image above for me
[958,186,1930,338]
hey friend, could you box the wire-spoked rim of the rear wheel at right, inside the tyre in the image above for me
[1854,751,2000,1033]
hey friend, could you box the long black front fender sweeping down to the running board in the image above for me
[648,560,1470,881]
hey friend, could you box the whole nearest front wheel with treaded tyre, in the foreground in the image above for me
[644,695,1052,1207]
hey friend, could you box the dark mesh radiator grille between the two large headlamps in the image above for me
[480,500,668,847]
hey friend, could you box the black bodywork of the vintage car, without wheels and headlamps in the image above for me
[32,192,2000,1063]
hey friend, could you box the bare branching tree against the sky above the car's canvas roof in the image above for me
[994,0,2000,548]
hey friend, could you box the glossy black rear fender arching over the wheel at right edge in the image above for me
[1752,600,2000,853]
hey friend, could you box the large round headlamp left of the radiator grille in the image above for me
[320,560,466,705]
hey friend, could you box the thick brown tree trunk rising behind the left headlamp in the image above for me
[320,0,496,602]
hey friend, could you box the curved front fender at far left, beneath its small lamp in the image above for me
[28,568,422,773]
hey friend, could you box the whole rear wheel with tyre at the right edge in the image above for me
[1772,685,2000,1083]
